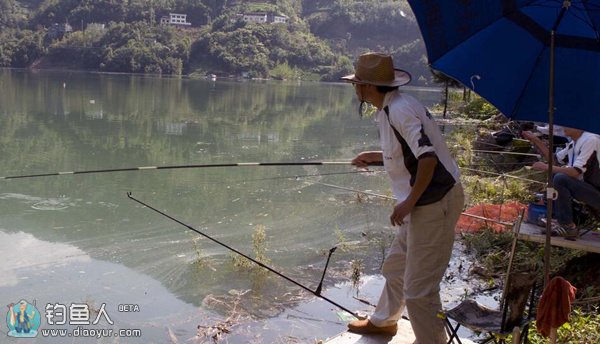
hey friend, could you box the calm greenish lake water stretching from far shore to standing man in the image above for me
[0,70,460,343]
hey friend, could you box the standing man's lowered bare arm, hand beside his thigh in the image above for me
[390,154,438,226]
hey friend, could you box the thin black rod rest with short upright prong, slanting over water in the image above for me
[127,192,359,318]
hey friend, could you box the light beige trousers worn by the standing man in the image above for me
[369,183,464,344]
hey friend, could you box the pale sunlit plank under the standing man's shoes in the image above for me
[324,319,474,344]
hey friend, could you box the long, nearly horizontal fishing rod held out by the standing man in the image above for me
[0,161,350,179]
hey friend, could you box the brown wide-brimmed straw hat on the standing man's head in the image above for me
[342,53,411,87]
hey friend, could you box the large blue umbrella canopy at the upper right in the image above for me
[408,0,600,133]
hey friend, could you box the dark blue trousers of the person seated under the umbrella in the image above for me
[553,173,600,225]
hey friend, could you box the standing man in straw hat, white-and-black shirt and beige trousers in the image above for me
[342,53,464,344]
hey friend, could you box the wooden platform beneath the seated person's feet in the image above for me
[519,222,600,253]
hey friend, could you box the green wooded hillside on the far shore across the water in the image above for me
[0,0,429,84]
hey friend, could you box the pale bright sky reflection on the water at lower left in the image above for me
[0,232,211,343]
